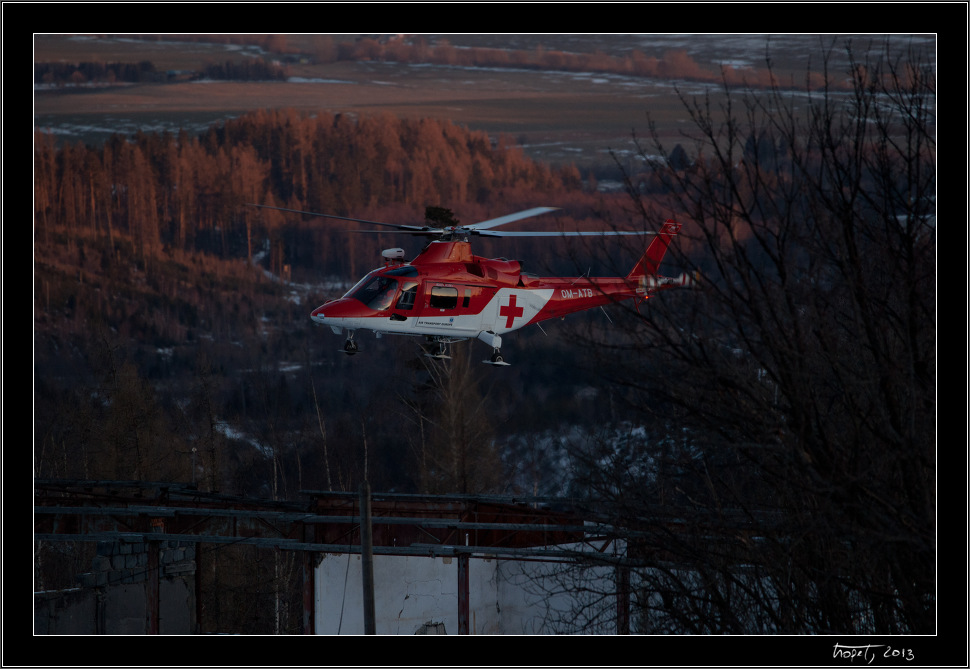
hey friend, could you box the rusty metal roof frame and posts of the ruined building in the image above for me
[34,480,629,634]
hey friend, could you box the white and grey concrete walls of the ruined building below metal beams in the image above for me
[34,542,616,635]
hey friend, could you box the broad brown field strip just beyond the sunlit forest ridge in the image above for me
[35,71,680,172]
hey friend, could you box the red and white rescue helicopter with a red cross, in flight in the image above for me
[251,204,696,366]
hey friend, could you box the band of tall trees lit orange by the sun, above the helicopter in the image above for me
[34,110,581,272]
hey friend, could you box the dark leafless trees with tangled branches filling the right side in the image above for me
[564,39,937,634]
